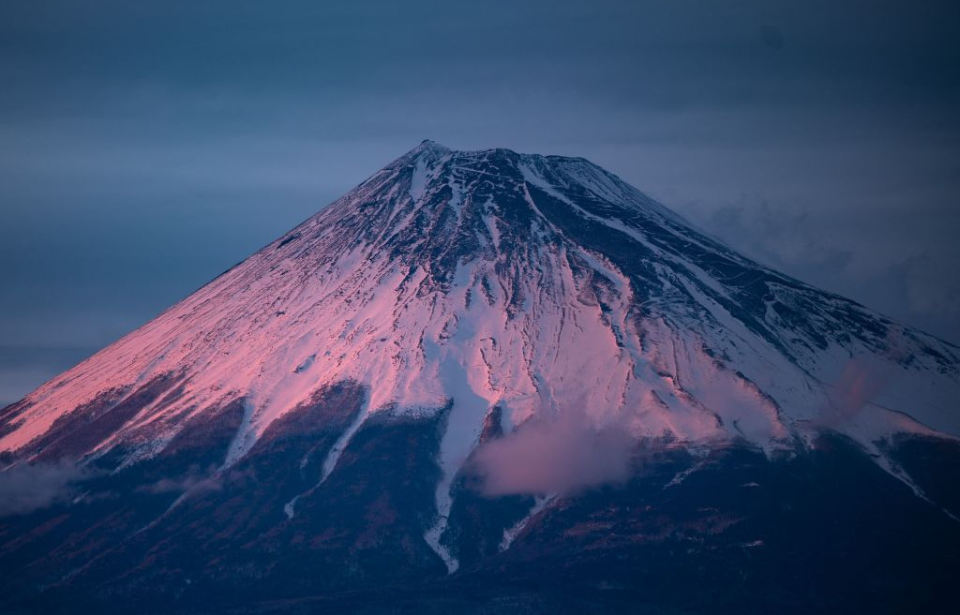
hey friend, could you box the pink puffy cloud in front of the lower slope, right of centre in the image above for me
[472,410,637,496]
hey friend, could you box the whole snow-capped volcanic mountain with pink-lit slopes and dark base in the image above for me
[0,141,960,613]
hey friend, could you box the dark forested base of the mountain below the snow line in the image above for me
[0,430,960,614]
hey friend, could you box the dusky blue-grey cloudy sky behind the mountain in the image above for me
[0,0,960,405]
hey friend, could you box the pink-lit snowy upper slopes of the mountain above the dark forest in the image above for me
[0,141,960,506]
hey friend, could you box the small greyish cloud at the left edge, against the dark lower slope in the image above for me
[0,463,90,517]
